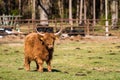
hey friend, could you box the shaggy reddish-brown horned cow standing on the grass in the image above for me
[24,32,60,72]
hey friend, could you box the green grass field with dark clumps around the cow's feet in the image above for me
[0,36,120,80]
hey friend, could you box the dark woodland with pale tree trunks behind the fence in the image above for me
[0,0,120,19]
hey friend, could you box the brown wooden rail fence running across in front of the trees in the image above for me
[0,16,120,35]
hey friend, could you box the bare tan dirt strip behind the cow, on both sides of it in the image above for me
[0,35,120,45]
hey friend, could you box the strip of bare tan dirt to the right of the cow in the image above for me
[56,36,120,44]
